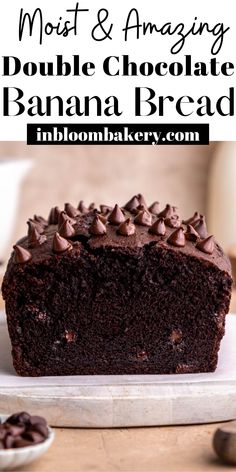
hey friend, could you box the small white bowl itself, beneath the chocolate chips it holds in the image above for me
[0,415,55,470]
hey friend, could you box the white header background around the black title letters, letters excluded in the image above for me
[0,0,236,141]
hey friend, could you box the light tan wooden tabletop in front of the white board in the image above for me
[0,282,235,472]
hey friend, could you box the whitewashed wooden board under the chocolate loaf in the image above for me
[0,315,236,427]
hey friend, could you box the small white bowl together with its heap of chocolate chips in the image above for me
[0,412,54,470]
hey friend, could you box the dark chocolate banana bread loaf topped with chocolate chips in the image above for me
[2,194,232,376]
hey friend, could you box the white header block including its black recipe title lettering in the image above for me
[0,0,236,141]
